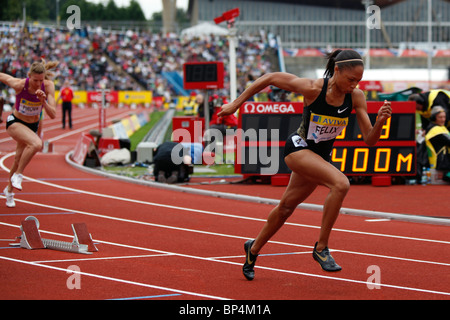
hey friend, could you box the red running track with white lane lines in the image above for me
[0,109,450,306]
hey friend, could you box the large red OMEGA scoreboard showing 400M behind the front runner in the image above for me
[235,101,416,176]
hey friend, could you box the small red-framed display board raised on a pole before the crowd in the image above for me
[183,62,224,90]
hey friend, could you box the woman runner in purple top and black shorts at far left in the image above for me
[0,60,58,208]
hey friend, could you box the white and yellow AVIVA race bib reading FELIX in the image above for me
[307,113,348,143]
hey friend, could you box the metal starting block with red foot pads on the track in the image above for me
[12,216,98,254]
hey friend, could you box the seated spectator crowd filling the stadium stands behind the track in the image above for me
[0,25,272,107]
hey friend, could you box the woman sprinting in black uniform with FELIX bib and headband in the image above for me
[219,50,392,280]
